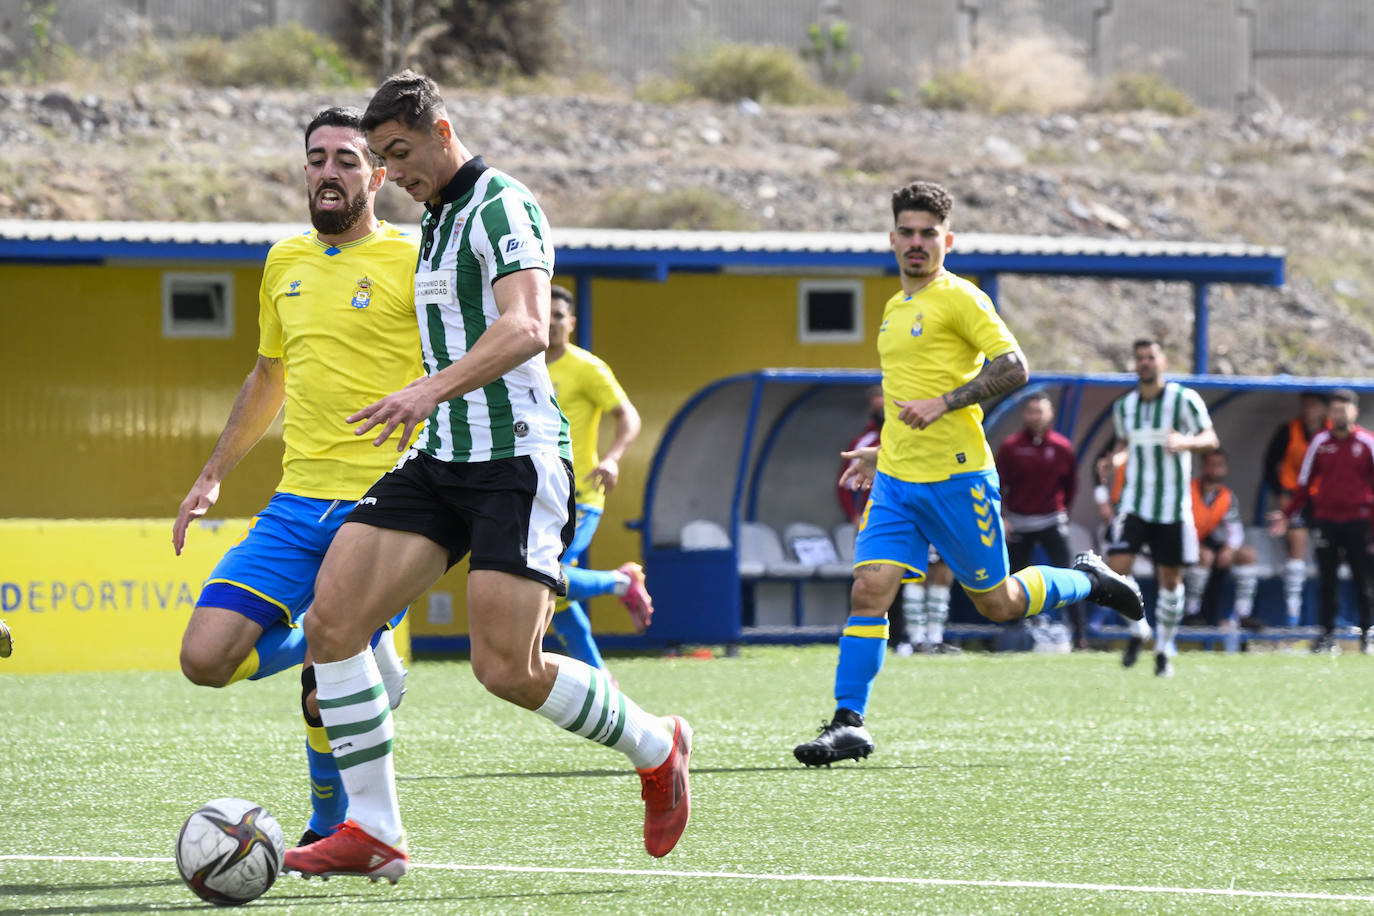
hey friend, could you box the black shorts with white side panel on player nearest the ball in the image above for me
[348,449,577,595]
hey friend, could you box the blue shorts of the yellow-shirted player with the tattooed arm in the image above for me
[855,468,1010,592]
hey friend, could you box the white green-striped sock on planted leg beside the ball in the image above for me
[315,648,405,846]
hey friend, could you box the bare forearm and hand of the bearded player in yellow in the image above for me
[172,356,286,556]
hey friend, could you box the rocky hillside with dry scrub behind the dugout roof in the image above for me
[0,87,1374,375]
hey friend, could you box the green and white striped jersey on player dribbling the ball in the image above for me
[415,157,573,463]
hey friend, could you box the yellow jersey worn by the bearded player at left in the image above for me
[258,222,425,500]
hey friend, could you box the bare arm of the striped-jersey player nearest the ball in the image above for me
[346,269,550,452]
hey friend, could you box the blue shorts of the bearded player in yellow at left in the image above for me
[195,493,405,629]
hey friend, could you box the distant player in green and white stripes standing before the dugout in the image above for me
[1107,339,1220,677]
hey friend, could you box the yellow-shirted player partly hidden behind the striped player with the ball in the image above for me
[544,286,654,669]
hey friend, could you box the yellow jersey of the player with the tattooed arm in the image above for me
[878,273,1018,483]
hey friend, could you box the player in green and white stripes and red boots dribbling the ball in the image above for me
[286,70,691,882]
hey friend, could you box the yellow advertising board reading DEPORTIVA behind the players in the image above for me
[0,519,409,674]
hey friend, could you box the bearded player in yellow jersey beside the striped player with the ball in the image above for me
[172,108,423,843]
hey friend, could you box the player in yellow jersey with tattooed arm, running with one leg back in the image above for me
[793,181,1143,766]
